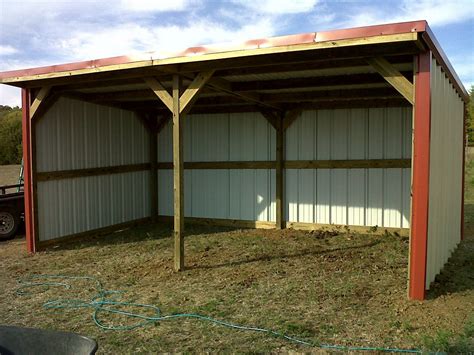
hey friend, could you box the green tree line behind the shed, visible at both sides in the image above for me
[0,85,474,165]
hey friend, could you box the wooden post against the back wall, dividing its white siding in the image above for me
[275,117,285,229]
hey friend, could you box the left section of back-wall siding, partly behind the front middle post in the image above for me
[158,113,275,221]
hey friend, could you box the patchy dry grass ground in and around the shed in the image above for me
[0,163,474,354]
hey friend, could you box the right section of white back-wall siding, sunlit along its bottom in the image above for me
[285,108,412,228]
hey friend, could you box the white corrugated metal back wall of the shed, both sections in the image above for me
[158,108,412,228]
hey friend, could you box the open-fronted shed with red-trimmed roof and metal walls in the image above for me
[0,21,467,299]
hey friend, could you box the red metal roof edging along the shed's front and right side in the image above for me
[0,20,468,98]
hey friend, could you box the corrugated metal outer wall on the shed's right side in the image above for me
[426,59,464,289]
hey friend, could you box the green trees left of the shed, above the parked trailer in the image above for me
[0,105,23,165]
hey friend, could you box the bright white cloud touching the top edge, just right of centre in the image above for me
[233,0,319,15]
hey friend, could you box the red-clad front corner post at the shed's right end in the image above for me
[408,51,431,300]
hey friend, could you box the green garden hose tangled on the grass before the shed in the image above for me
[16,275,421,353]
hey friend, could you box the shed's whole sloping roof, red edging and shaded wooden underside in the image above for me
[0,21,468,112]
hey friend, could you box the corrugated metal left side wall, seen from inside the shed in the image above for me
[36,98,150,241]
